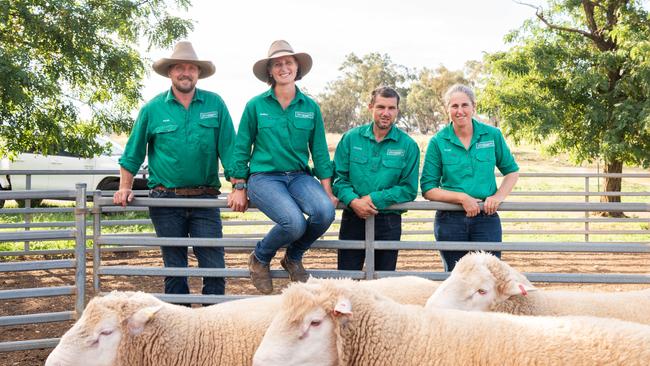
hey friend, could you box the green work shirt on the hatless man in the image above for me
[332,122,420,213]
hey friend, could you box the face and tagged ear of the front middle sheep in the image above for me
[253,284,350,366]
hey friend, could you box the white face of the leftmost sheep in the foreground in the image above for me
[45,306,122,366]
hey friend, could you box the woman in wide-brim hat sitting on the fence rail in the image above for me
[228,41,338,294]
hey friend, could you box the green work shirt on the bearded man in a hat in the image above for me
[119,89,235,188]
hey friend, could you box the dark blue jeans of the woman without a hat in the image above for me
[433,211,502,272]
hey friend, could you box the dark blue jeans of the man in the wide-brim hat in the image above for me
[149,191,226,295]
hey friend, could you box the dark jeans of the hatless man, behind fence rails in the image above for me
[338,210,402,271]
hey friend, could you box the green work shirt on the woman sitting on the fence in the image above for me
[232,87,332,179]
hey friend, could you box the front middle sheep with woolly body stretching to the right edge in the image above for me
[253,279,650,366]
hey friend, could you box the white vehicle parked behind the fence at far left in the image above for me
[0,137,147,207]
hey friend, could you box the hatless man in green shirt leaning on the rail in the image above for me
[333,87,420,271]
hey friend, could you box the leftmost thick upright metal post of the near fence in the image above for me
[74,183,87,318]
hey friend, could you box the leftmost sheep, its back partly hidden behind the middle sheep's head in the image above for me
[46,276,437,366]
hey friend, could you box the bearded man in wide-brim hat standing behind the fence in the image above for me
[113,42,235,295]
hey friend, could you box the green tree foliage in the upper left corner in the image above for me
[0,0,192,157]
